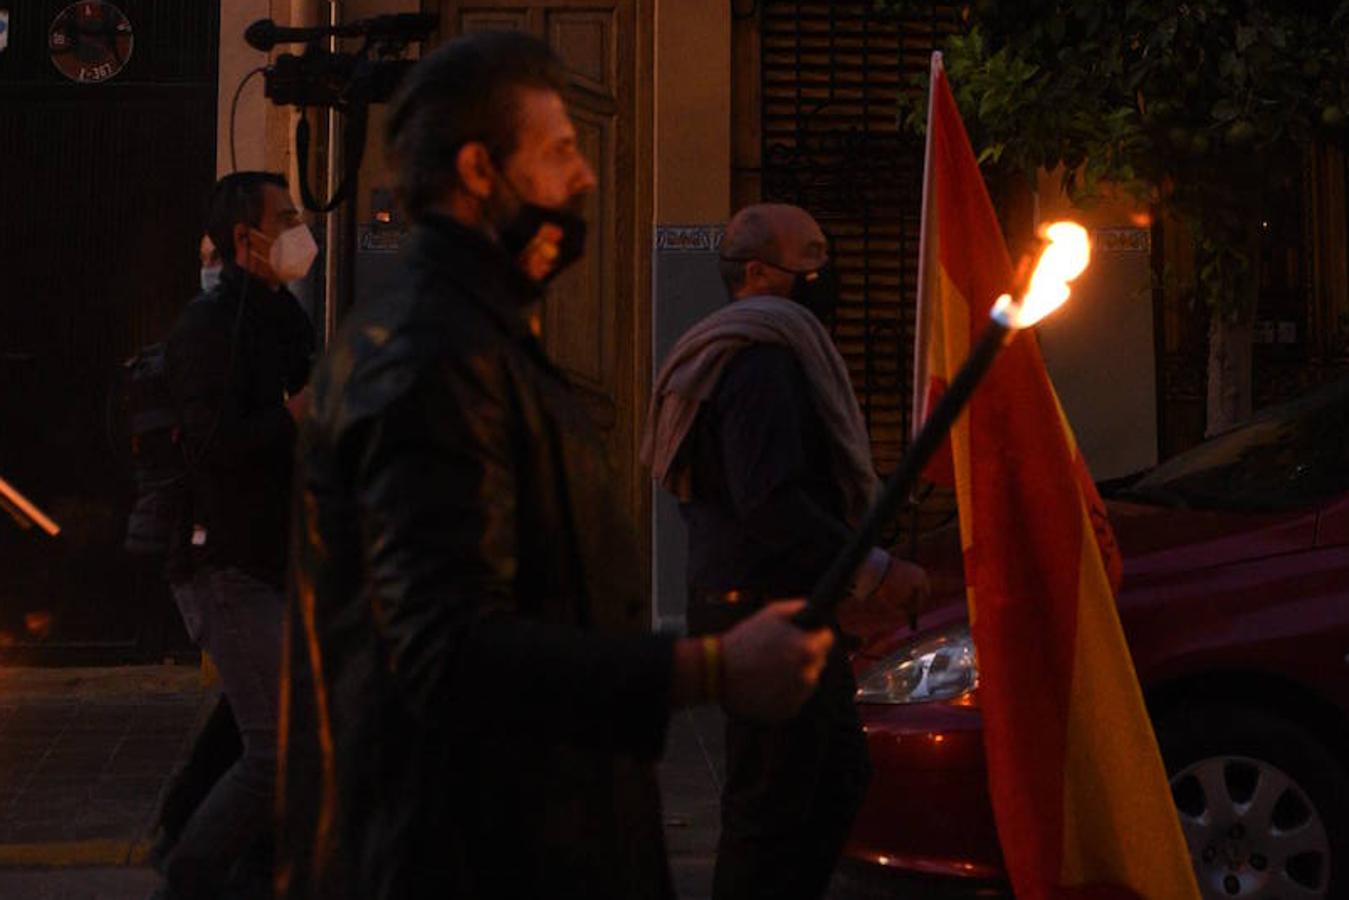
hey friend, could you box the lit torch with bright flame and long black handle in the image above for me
[796,221,1091,627]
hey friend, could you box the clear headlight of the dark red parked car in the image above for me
[857,622,979,703]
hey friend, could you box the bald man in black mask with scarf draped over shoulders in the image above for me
[643,204,927,900]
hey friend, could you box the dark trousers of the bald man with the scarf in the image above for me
[688,599,871,900]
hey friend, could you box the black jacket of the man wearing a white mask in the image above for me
[167,266,314,587]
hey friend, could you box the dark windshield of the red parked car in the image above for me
[1116,379,1349,511]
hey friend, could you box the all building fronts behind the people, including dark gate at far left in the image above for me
[0,0,1349,647]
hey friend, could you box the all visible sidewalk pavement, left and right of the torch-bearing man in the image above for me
[0,665,998,900]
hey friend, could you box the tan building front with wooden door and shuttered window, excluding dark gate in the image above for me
[229,0,1157,626]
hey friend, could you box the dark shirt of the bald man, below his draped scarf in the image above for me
[681,344,849,596]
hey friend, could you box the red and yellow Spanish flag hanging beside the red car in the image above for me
[915,54,1199,900]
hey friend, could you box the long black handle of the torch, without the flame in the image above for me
[793,320,1012,629]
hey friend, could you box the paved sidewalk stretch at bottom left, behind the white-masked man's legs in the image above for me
[0,665,208,900]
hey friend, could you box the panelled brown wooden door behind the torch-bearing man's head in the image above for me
[438,0,650,591]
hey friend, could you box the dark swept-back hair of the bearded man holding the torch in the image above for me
[386,31,567,220]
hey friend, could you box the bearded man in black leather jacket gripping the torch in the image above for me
[277,31,834,900]
